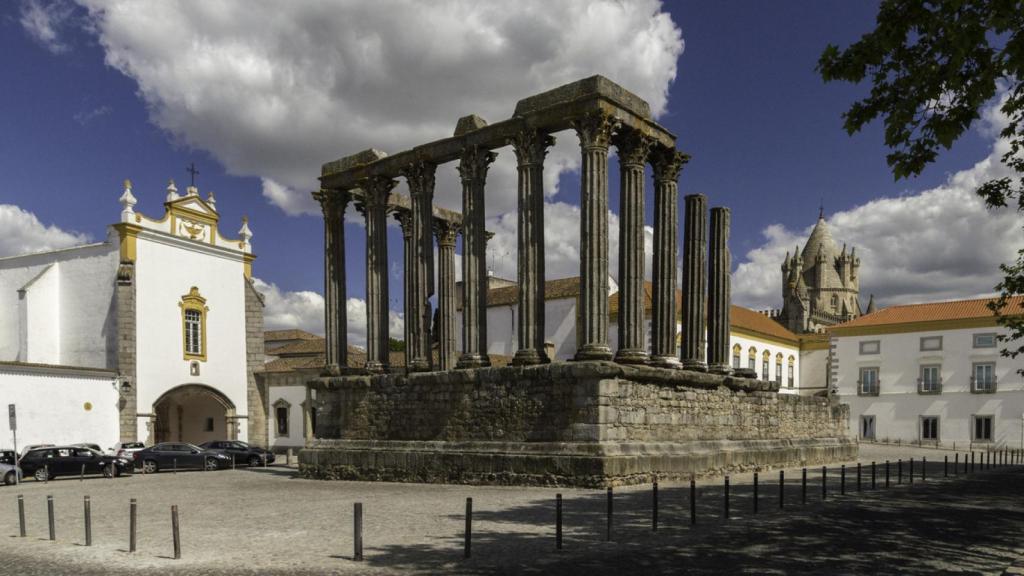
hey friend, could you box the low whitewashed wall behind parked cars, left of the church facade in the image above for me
[0,365,119,450]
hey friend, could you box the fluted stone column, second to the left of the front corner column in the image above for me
[458,147,498,368]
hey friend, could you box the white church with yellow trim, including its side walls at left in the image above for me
[0,177,266,449]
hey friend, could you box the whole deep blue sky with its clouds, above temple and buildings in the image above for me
[0,0,1020,338]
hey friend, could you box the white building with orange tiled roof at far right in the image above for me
[830,298,1024,448]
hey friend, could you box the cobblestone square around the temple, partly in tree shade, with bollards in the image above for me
[0,445,1024,576]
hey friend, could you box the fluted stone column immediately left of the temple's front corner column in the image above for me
[512,128,555,365]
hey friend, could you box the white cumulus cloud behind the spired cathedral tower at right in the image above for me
[733,130,1024,308]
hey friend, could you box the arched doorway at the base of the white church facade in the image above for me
[153,384,238,444]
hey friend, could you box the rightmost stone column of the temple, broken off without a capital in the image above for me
[708,208,732,374]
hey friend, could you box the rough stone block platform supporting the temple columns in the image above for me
[299,362,857,487]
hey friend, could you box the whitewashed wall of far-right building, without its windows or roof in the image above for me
[833,327,1024,448]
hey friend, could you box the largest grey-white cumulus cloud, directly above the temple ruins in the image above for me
[66,0,683,216]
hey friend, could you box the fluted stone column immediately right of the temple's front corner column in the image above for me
[614,130,651,364]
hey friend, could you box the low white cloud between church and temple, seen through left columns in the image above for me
[253,278,404,346]
